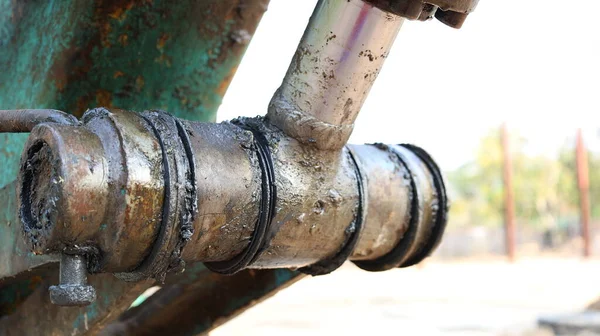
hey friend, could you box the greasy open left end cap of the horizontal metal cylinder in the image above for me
[17,124,106,254]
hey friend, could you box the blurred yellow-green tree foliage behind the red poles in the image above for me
[447,130,600,227]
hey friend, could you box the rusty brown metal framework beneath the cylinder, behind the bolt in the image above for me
[0,263,302,336]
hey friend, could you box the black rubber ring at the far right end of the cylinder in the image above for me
[399,144,448,267]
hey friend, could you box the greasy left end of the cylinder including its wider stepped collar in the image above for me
[18,110,164,272]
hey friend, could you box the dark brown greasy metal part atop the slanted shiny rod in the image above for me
[364,0,479,28]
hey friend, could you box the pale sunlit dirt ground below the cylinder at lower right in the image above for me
[211,258,600,336]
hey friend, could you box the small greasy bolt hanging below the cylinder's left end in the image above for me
[49,253,96,306]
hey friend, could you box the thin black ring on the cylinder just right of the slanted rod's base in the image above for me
[298,150,365,276]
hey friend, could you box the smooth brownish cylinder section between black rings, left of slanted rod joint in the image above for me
[183,122,261,261]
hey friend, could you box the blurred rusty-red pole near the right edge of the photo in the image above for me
[575,128,591,258]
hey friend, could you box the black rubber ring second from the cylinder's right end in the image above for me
[353,144,419,272]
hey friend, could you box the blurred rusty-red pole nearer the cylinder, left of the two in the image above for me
[501,123,516,262]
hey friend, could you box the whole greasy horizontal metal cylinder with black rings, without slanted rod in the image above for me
[19,109,445,280]
